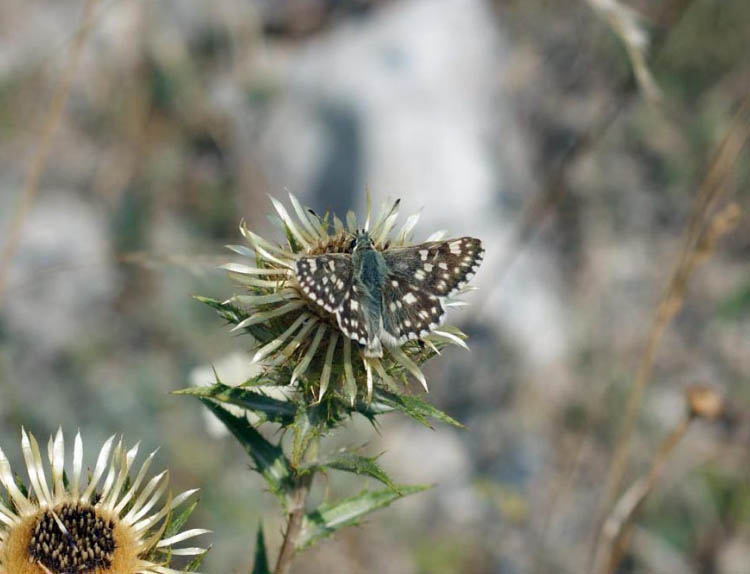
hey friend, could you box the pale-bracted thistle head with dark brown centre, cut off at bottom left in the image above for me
[0,430,208,574]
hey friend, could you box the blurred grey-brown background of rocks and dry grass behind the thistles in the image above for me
[0,0,750,574]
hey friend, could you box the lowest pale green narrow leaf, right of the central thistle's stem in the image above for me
[296,484,430,550]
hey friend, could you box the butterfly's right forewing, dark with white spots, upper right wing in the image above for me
[383,237,484,297]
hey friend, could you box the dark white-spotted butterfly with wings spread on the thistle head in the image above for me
[295,231,484,357]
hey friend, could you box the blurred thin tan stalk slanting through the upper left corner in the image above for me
[0,0,97,306]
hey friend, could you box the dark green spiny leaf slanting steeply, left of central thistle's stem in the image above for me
[199,398,291,504]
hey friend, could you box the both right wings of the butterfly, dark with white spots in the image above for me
[381,237,484,346]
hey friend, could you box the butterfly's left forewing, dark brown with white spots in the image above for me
[295,253,352,313]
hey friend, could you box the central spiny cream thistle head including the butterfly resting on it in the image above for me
[220,194,484,403]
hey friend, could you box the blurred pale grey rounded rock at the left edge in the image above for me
[1,190,116,361]
